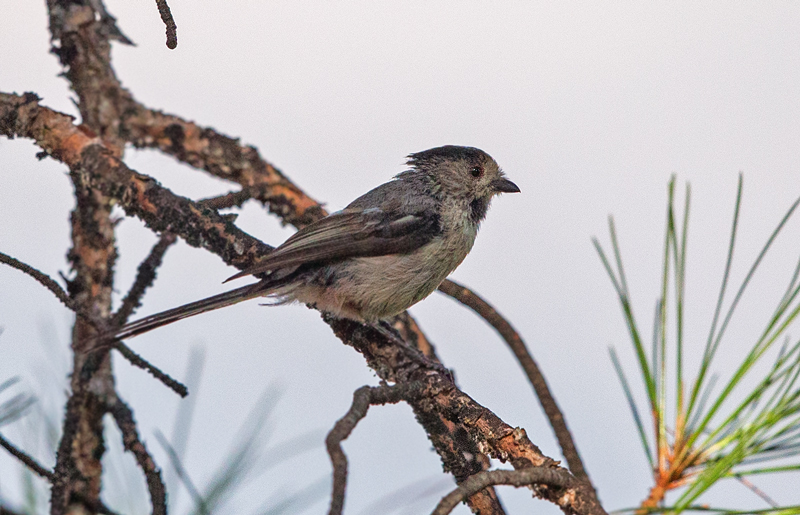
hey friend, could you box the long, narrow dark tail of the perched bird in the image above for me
[108,282,270,340]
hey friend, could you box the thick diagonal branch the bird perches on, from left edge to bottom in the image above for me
[0,94,602,513]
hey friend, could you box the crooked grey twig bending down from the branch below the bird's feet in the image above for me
[325,383,419,515]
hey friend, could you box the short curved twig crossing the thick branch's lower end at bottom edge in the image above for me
[431,467,577,515]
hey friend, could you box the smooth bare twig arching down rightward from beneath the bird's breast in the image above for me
[439,280,597,497]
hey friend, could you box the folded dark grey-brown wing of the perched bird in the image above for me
[226,208,440,282]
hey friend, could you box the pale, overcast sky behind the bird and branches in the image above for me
[0,0,800,515]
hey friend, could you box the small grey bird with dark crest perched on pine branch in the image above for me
[107,145,520,340]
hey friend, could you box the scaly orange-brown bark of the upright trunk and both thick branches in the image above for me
[0,4,605,515]
